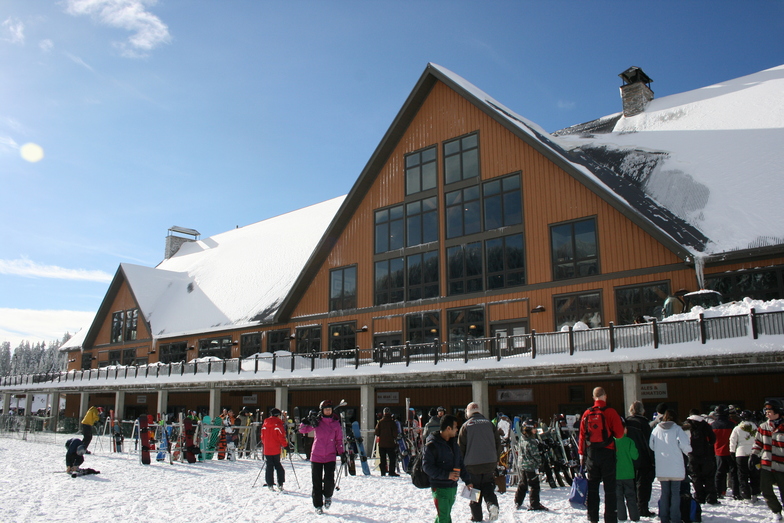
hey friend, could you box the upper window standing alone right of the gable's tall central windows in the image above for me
[550,218,599,280]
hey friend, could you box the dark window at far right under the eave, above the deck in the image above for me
[705,267,784,303]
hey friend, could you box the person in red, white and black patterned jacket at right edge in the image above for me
[749,400,784,521]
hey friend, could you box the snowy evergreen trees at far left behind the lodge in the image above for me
[0,333,71,376]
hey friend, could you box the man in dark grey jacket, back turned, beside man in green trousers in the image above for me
[457,402,503,521]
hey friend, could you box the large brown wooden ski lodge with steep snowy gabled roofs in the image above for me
[0,64,784,432]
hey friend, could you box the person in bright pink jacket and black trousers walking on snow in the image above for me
[299,400,346,514]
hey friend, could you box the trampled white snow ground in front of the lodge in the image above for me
[0,434,771,523]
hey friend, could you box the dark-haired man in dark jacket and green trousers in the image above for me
[422,414,472,523]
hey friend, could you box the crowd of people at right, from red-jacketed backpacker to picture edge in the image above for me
[579,387,784,523]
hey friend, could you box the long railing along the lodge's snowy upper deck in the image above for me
[0,309,784,386]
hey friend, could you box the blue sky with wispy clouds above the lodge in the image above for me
[0,0,784,346]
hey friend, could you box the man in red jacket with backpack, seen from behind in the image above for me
[578,387,623,523]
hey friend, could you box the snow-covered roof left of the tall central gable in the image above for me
[112,196,345,338]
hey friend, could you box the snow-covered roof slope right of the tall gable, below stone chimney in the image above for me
[553,66,784,255]
